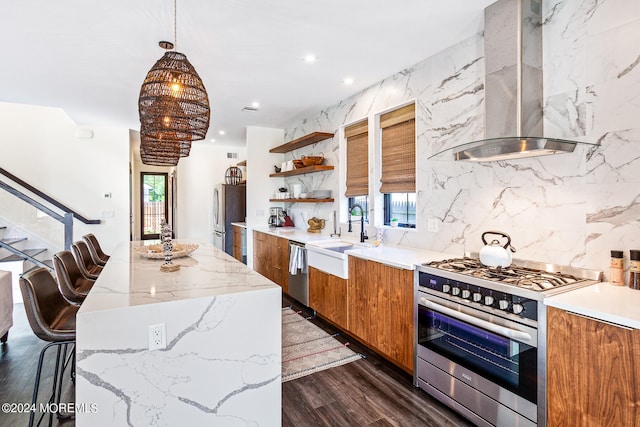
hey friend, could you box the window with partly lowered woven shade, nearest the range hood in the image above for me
[380,104,416,228]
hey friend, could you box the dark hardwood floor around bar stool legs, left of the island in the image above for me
[0,304,75,427]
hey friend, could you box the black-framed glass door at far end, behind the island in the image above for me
[140,172,173,240]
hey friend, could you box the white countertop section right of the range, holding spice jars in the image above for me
[544,282,640,329]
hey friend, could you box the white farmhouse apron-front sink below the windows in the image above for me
[306,239,373,279]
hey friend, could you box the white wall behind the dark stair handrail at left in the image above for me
[0,103,129,253]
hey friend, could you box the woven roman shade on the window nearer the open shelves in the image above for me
[344,120,369,197]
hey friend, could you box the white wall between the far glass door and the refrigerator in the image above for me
[176,141,247,243]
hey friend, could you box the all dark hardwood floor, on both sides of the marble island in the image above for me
[0,297,472,427]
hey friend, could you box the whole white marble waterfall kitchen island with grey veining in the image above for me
[76,242,282,427]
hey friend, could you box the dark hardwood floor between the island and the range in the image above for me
[282,297,473,427]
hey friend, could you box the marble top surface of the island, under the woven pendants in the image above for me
[79,240,278,313]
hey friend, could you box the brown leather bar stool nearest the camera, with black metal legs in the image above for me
[20,268,78,426]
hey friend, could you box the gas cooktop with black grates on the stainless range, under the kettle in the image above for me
[419,257,602,300]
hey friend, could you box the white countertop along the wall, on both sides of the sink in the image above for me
[254,227,461,270]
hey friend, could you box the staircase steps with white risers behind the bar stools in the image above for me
[0,225,53,303]
